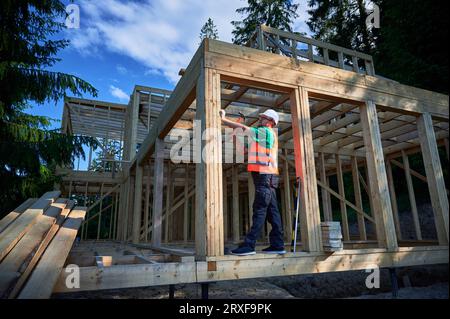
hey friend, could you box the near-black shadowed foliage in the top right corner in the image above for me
[374,0,449,94]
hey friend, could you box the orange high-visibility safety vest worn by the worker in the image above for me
[247,129,278,175]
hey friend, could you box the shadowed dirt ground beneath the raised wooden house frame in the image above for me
[52,264,448,299]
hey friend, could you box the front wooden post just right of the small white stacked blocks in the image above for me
[359,100,398,250]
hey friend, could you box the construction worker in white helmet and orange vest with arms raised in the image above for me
[220,109,286,256]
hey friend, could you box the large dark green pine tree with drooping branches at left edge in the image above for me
[0,0,97,216]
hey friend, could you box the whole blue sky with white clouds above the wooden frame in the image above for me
[28,0,310,128]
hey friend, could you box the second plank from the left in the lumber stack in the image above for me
[0,191,61,261]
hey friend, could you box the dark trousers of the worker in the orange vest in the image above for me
[245,172,284,248]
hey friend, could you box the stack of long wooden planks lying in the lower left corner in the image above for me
[0,191,86,299]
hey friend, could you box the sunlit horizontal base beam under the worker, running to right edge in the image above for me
[197,246,448,282]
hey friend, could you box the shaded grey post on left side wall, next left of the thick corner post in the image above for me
[152,138,167,246]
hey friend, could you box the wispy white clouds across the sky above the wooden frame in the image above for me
[72,0,312,83]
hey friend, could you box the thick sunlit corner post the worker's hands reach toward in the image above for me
[195,68,224,260]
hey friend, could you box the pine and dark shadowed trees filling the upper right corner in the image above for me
[307,0,449,94]
